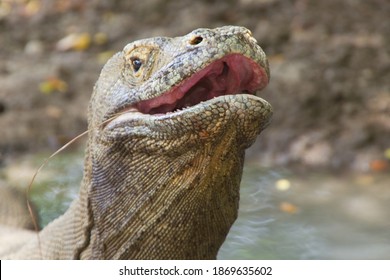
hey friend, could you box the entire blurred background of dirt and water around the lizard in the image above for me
[0,0,390,259]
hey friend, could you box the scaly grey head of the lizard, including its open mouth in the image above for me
[90,26,272,146]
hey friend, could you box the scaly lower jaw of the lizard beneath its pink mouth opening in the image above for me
[104,94,272,140]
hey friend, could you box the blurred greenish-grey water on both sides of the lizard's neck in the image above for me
[5,152,390,259]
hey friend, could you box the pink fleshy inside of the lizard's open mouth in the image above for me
[133,54,268,115]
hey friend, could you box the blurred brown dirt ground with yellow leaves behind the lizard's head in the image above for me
[0,0,390,172]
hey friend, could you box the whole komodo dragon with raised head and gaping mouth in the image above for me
[0,26,272,259]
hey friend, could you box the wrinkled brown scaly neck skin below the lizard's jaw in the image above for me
[81,119,244,259]
